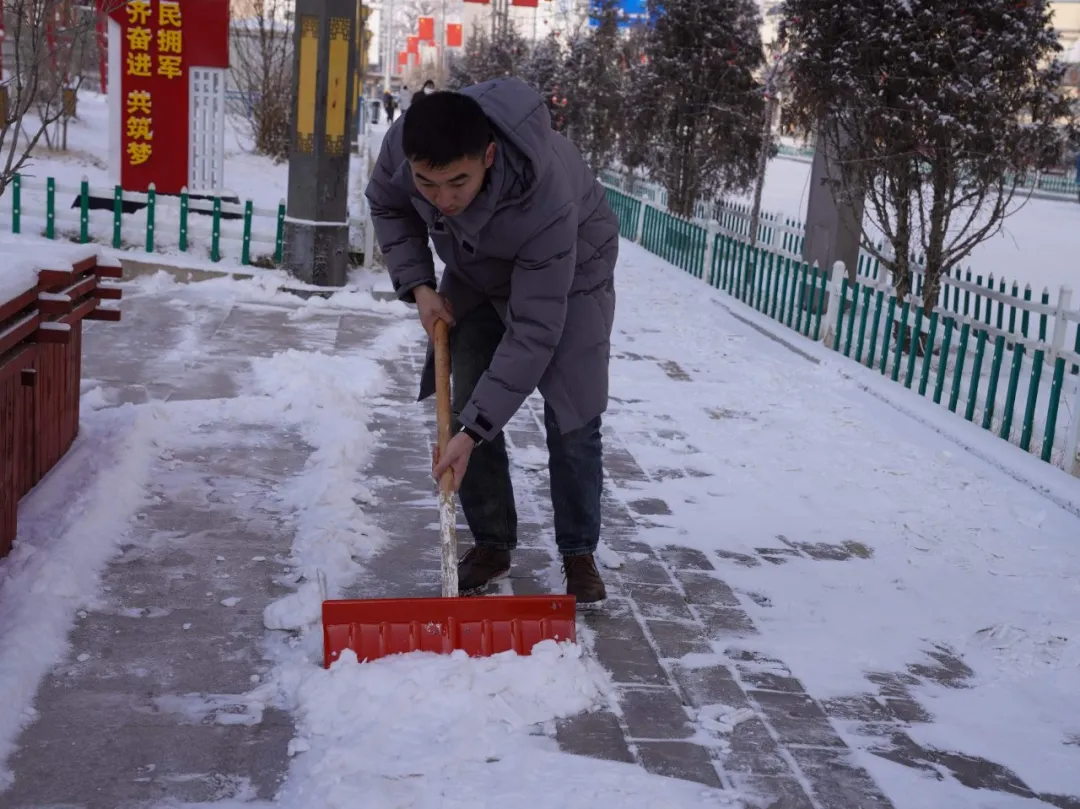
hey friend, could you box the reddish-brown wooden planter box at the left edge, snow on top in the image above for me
[0,254,122,557]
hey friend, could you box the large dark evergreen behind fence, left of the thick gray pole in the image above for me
[634,0,765,216]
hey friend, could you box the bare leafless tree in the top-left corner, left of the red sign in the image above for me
[0,0,120,194]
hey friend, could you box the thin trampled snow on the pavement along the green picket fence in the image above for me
[609,236,1080,809]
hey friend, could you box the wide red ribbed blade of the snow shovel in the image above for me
[323,595,577,669]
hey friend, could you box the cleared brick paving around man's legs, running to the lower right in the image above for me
[355,336,1080,809]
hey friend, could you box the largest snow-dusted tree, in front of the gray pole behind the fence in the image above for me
[782,0,1075,312]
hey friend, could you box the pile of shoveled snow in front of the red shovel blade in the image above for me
[181,641,741,809]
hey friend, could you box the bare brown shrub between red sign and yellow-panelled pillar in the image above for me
[230,0,293,163]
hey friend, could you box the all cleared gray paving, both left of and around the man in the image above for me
[0,278,1080,809]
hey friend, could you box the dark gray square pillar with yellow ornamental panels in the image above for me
[282,0,357,286]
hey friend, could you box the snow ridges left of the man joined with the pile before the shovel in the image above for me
[0,273,739,809]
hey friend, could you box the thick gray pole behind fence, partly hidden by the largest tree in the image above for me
[802,115,864,308]
